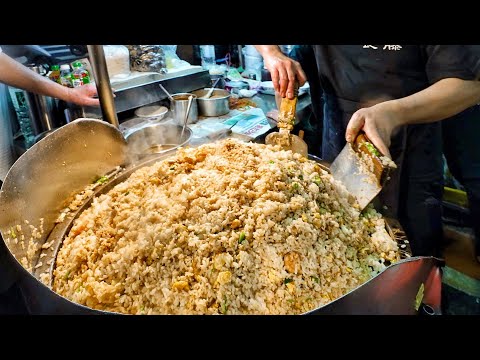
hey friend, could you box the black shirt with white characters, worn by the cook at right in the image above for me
[313,45,480,105]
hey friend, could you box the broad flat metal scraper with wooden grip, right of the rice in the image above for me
[330,132,390,210]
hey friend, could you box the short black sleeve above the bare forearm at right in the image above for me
[424,45,480,84]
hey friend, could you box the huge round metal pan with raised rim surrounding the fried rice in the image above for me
[0,119,441,314]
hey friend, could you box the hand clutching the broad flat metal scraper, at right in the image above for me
[345,101,401,158]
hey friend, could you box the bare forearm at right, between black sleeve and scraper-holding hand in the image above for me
[392,78,480,125]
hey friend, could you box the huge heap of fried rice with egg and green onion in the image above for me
[53,139,399,314]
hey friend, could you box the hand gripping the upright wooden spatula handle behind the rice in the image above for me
[263,52,307,99]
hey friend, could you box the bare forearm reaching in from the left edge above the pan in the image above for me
[0,53,70,101]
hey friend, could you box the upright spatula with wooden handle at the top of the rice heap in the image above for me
[265,83,308,157]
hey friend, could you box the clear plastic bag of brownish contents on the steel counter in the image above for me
[127,45,167,74]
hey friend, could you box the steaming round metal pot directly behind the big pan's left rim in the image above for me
[125,123,192,157]
